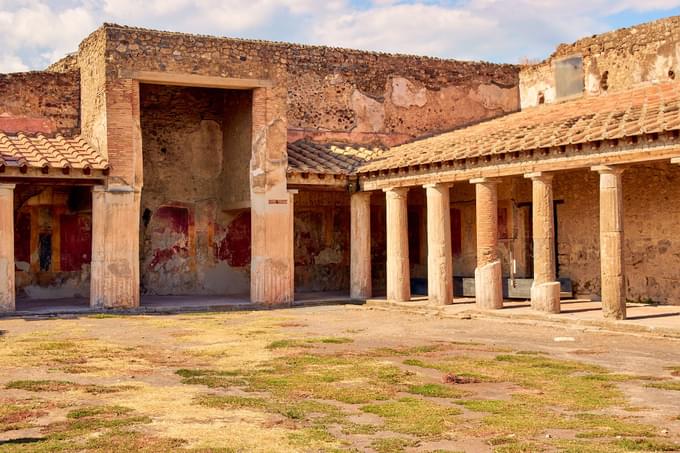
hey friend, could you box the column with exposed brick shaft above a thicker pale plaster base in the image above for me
[470,178,503,309]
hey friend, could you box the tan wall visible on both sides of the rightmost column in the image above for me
[555,163,680,305]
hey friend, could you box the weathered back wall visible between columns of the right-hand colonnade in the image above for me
[440,168,680,305]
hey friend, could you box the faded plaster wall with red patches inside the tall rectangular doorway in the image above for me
[140,85,252,295]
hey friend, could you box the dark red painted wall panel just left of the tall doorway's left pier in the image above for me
[59,214,92,272]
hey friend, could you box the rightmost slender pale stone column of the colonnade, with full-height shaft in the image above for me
[593,166,626,319]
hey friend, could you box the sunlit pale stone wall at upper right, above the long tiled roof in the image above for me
[520,16,680,108]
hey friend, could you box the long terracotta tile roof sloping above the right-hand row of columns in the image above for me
[357,82,680,173]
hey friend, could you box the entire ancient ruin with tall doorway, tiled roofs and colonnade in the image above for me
[0,17,680,319]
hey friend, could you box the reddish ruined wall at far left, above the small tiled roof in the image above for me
[0,71,80,135]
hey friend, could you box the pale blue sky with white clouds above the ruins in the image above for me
[0,0,680,73]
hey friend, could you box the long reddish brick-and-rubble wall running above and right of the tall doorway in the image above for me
[99,26,519,144]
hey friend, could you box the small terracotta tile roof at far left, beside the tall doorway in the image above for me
[0,132,109,172]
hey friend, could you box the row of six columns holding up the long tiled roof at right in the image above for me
[350,166,626,319]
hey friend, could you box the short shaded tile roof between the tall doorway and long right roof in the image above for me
[288,140,385,175]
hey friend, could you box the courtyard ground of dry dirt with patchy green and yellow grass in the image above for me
[0,306,680,453]
